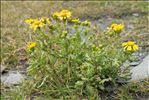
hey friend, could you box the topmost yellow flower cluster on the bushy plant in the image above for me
[53,10,71,20]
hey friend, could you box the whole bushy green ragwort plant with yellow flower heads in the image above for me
[25,10,138,99]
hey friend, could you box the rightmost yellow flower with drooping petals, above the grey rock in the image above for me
[122,41,139,52]
